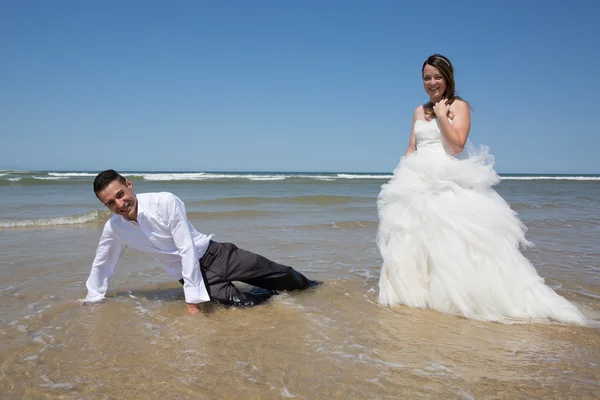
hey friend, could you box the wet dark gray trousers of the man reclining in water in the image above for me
[180,240,320,306]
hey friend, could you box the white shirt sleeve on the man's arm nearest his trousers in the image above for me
[167,195,210,304]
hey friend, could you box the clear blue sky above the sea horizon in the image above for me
[0,0,600,173]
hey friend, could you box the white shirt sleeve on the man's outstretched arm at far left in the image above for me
[84,223,127,302]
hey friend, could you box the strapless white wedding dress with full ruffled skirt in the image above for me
[377,119,585,324]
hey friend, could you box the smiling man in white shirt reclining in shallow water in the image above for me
[84,169,321,315]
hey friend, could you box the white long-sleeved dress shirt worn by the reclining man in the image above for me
[84,192,212,303]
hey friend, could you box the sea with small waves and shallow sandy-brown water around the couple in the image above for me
[0,170,600,399]
